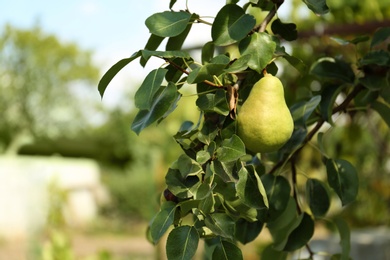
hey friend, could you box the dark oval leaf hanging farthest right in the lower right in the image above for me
[326,159,359,206]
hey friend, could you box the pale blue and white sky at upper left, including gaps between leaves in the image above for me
[0,0,292,105]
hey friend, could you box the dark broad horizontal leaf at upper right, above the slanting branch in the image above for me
[310,58,355,84]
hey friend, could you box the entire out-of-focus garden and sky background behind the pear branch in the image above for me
[0,0,390,260]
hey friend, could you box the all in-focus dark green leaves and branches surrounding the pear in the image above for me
[99,0,390,259]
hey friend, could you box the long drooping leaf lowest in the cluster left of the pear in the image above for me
[131,84,181,135]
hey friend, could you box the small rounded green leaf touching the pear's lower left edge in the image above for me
[217,135,246,162]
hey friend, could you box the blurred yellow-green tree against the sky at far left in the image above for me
[0,25,99,152]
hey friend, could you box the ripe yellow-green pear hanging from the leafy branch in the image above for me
[237,74,294,153]
